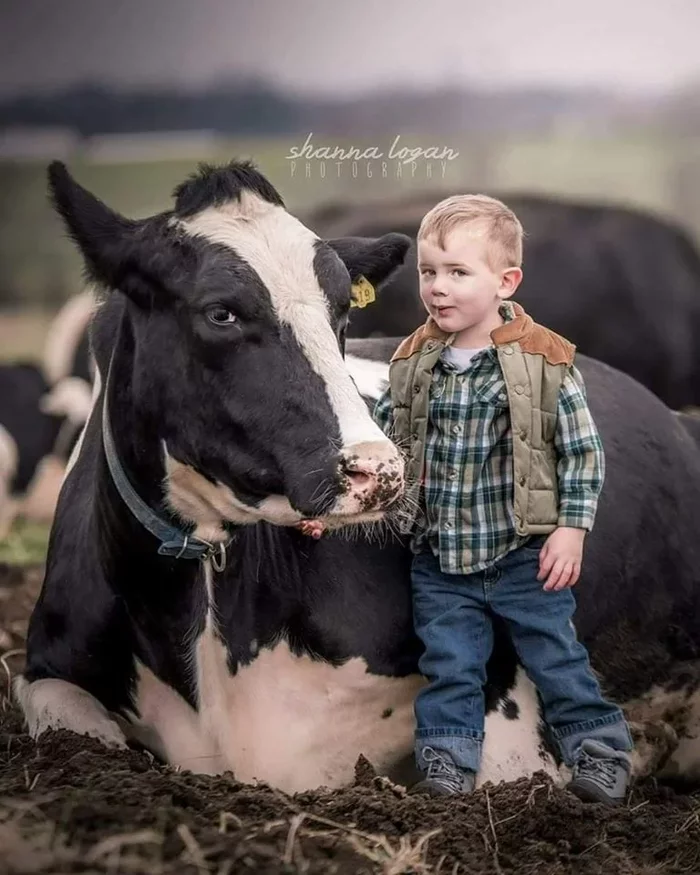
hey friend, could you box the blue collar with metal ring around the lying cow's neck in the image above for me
[102,380,226,571]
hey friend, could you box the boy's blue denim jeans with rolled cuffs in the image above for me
[411,537,633,772]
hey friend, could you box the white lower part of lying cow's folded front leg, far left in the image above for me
[13,675,126,747]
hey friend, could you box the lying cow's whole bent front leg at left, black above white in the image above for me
[14,486,135,745]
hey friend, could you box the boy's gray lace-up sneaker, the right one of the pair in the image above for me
[567,739,630,805]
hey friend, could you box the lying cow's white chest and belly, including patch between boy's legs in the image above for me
[132,574,557,793]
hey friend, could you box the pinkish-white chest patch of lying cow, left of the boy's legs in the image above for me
[196,628,424,793]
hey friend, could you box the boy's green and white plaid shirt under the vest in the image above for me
[374,347,605,574]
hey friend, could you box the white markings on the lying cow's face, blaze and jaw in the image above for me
[168,192,403,537]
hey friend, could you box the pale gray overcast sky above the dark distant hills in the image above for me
[0,0,700,94]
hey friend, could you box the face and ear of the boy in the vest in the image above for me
[418,222,522,334]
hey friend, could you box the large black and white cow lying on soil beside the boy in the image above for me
[15,157,700,792]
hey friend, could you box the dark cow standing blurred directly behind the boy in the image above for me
[305,192,700,408]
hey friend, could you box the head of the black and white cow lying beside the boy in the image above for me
[49,162,410,525]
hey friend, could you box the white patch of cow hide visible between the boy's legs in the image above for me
[477,666,563,787]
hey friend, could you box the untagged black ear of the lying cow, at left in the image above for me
[48,161,179,307]
